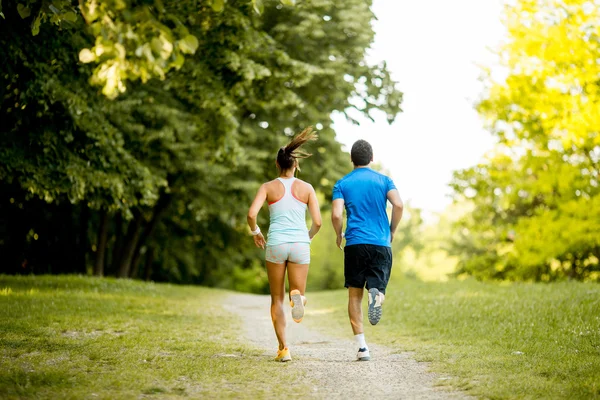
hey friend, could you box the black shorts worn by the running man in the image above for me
[344,244,392,293]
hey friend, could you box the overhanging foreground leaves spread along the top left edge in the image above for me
[0,0,302,98]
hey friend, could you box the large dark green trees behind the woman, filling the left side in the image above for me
[0,0,401,291]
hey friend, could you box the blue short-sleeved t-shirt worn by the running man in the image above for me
[333,168,396,247]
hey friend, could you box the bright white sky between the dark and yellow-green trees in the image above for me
[334,0,504,219]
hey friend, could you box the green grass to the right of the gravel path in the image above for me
[305,279,600,399]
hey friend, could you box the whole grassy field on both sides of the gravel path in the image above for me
[0,275,600,399]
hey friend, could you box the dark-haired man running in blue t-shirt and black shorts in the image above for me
[331,140,404,361]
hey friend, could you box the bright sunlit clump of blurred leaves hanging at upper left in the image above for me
[79,0,199,98]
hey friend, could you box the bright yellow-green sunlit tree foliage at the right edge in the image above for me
[452,0,600,280]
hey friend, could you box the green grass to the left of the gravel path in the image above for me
[0,275,308,399]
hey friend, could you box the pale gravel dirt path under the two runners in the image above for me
[227,294,468,400]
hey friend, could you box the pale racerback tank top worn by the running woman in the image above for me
[267,178,310,246]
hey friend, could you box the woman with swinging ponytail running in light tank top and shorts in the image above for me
[248,127,321,361]
